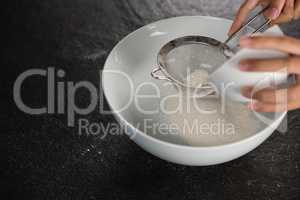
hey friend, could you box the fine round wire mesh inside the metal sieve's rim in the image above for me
[158,36,227,87]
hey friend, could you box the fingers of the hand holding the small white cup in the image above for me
[240,36,300,112]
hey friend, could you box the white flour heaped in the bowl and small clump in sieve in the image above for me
[148,66,261,146]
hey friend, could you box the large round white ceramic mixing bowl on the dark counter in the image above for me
[102,16,286,166]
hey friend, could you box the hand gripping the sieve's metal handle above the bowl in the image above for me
[228,0,300,35]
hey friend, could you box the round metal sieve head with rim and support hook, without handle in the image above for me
[151,36,230,96]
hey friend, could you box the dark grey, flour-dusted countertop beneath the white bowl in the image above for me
[1,0,300,200]
